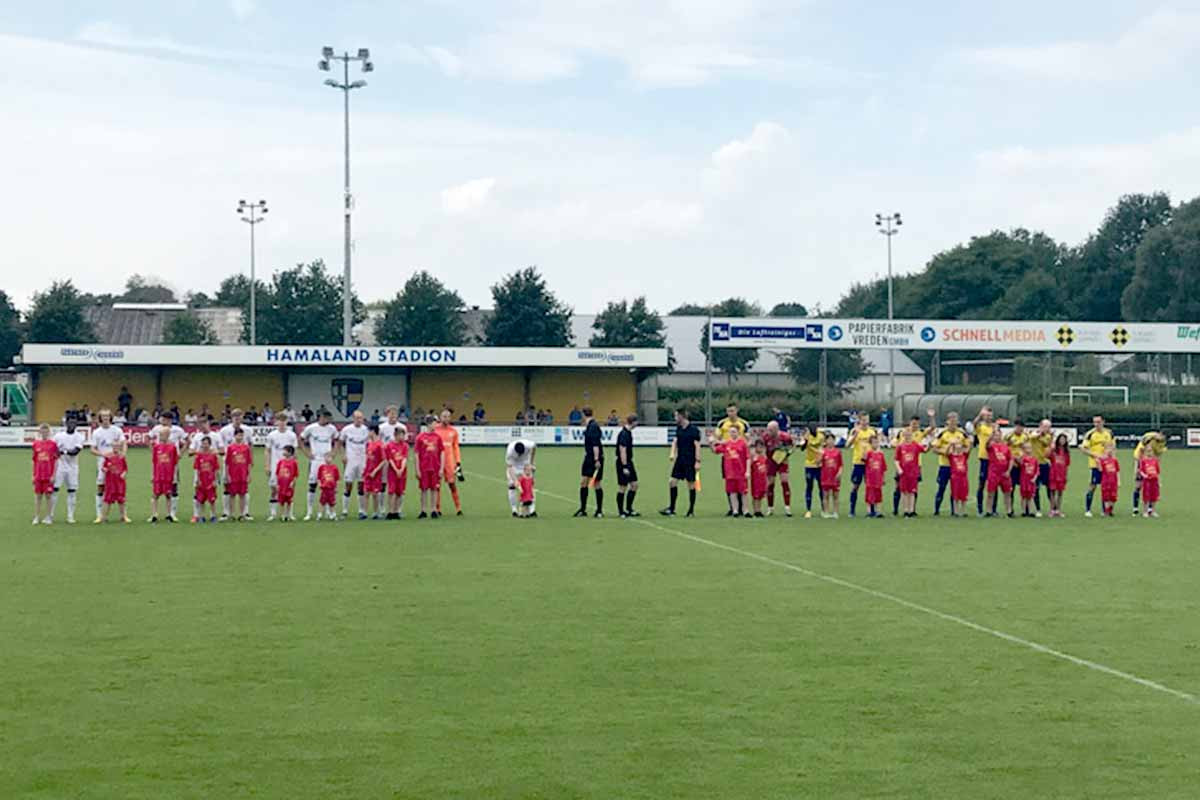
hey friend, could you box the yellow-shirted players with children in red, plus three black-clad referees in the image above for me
[559,405,1166,518]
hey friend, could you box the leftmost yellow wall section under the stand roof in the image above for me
[34,367,155,422]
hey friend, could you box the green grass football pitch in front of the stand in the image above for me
[0,449,1200,799]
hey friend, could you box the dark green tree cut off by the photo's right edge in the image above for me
[1121,198,1200,323]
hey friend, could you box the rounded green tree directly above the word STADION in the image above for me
[374,270,467,345]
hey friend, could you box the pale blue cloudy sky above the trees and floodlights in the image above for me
[0,0,1200,313]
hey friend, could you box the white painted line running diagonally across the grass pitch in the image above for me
[470,473,1200,705]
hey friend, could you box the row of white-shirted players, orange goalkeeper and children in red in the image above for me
[32,407,463,524]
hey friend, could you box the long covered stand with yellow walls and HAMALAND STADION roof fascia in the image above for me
[22,344,667,425]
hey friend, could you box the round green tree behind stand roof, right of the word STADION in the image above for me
[484,266,574,347]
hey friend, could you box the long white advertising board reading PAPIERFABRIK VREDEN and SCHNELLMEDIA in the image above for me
[709,317,1200,353]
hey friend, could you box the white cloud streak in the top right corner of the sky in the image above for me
[961,6,1200,83]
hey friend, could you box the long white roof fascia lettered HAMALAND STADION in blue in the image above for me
[22,344,667,369]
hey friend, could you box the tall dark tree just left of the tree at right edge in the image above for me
[1063,192,1172,321]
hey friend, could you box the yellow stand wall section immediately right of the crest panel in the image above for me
[409,368,524,423]
